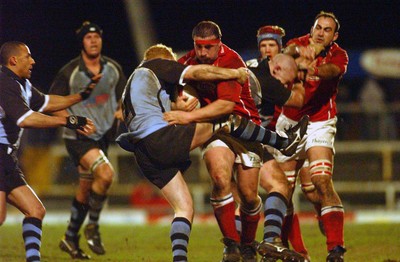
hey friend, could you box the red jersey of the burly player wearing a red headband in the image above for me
[178,44,261,124]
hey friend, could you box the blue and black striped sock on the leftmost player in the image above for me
[22,217,42,262]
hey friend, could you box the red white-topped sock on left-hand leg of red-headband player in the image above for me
[210,194,240,243]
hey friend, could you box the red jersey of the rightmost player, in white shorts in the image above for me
[283,34,349,122]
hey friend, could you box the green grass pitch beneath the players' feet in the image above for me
[0,222,400,262]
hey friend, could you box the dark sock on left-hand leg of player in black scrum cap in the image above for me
[65,198,89,241]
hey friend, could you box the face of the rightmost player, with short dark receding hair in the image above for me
[311,16,339,47]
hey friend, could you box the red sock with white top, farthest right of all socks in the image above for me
[321,206,344,251]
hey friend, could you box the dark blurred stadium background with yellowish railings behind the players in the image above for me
[0,0,400,219]
